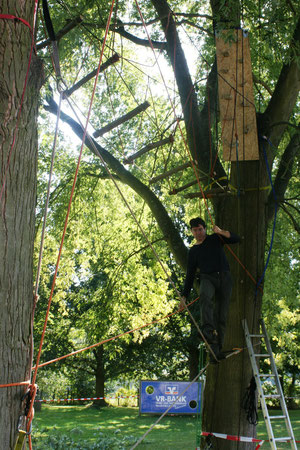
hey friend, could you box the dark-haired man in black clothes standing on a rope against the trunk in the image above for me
[181,217,240,362]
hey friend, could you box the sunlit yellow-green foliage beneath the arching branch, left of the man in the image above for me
[35,110,186,392]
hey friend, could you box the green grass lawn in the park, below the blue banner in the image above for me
[33,405,300,450]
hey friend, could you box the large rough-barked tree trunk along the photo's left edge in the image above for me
[0,1,41,450]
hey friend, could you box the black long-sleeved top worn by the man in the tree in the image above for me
[182,232,240,297]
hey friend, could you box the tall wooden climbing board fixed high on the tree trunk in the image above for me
[216,30,259,161]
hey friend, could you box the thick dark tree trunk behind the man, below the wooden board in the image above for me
[202,161,268,449]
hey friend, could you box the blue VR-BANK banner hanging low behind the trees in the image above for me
[140,381,201,414]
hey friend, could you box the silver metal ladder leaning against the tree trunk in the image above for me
[243,320,297,450]
